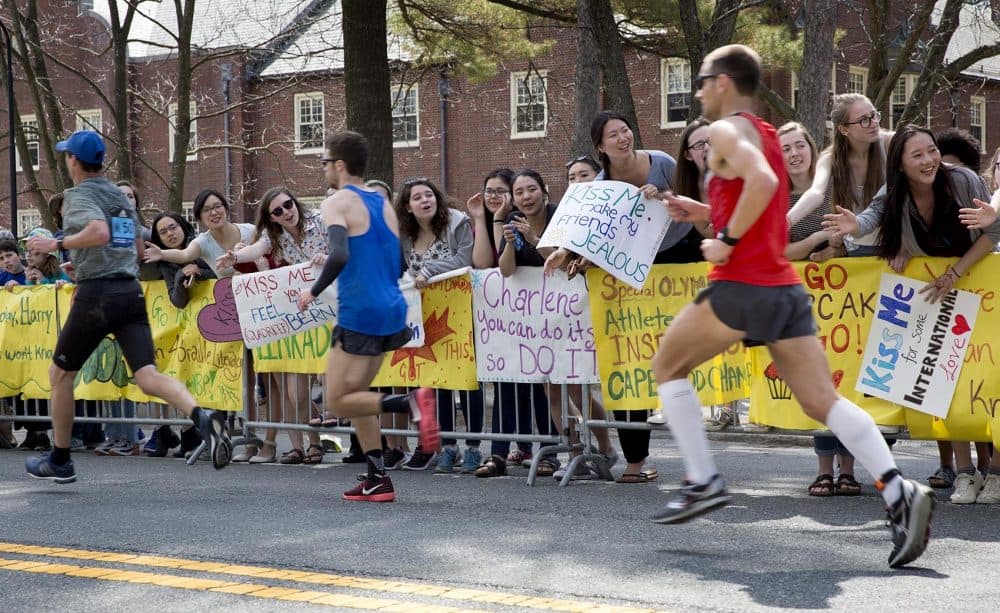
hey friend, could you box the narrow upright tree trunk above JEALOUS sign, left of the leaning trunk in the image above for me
[570,0,601,159]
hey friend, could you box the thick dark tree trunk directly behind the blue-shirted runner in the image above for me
[343,0,392,185]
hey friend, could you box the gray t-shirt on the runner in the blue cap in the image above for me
[63,177,142,282]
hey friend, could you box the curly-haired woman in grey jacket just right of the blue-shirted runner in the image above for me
[395,177,476,473]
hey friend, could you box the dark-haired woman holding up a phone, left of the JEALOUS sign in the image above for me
[498,168,559,477]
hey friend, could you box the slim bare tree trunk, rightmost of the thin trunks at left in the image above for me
[167,0,194,213]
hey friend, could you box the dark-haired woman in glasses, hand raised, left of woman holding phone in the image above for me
[462,168,545,478]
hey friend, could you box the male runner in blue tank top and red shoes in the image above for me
[298,132,441,502]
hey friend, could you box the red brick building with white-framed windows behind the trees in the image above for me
[0,0,1000,232]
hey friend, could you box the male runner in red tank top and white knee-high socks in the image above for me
[653,45,934,567]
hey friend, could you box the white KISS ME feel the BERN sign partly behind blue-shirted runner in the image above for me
[233,262,424,349]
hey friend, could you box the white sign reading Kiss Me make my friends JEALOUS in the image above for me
[538,181,670,289]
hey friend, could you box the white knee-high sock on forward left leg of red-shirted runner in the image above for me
[656,378,718,485]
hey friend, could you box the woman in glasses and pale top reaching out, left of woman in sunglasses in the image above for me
[146,189,254,279]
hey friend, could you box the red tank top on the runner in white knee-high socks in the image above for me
[708,113,801,287]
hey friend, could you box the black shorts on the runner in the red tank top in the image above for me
[694,281,816,347]
